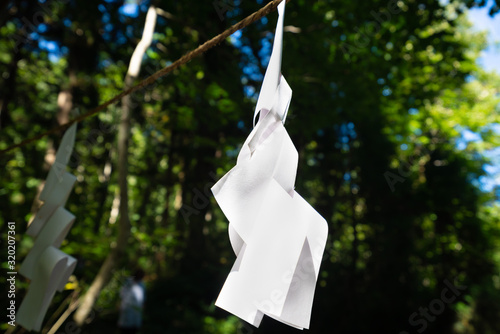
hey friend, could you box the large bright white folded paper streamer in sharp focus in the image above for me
[212,1,328,329]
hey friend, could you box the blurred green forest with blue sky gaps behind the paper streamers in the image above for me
[0,0,500,334]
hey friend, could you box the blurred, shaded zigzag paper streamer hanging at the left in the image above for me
[16,123,76,332]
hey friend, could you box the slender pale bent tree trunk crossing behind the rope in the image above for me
[74,6,156,326]
